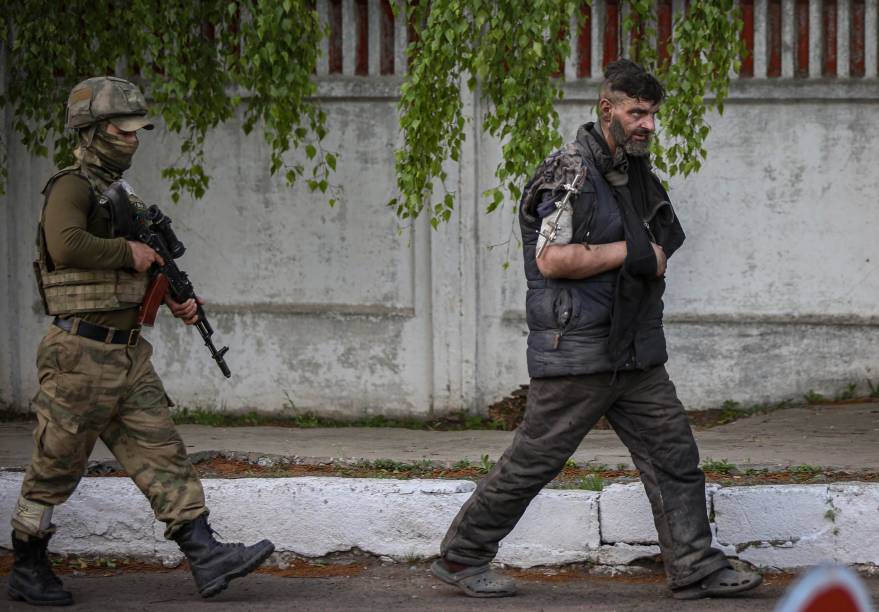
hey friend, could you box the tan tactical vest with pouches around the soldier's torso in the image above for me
[34,164,149,315]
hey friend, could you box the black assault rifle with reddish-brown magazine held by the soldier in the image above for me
[98,181,232,378]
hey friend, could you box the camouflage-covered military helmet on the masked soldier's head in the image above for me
[67,77,153,132]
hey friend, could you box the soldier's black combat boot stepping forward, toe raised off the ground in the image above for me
[174,514,275,597]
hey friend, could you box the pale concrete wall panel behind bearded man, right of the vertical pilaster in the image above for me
[478,80,879,408]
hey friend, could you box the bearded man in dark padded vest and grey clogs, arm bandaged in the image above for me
[432,60,762,599]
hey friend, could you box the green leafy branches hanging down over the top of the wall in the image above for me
[0,0,746,224]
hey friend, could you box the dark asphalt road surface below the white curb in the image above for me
[0,564,879,612]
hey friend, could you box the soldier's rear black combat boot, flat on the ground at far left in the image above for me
[6,531,73,606]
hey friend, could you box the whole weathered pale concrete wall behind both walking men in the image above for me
[0,4,879,417]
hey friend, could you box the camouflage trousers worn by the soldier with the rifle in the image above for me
[12,325,207,538]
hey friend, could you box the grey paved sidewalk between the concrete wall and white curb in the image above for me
[0,403,879,470]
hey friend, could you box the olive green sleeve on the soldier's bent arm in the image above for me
[43,175,134,270]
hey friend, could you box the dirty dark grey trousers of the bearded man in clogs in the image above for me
[442,366,730,589]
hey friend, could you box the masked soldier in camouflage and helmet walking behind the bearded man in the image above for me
[8,77,274,605]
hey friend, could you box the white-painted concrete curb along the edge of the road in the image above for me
[0,472,879,569]
